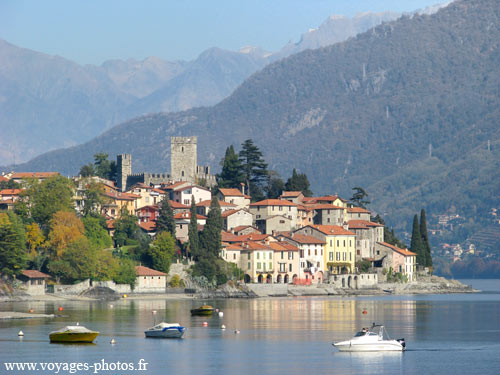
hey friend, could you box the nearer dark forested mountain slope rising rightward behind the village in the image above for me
[8,0,500,236]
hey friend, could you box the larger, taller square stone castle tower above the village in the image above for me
[170,137,198,183]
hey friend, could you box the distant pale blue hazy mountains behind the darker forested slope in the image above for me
[0,9,446,165]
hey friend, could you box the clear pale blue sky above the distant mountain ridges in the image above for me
[0,0,444,64]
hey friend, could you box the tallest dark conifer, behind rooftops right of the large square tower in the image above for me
[239,139,268,200]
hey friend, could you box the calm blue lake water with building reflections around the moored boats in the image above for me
[0,280,500,375]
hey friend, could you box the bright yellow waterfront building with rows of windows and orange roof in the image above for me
[296,225,356,274]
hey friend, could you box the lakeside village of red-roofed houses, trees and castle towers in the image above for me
[0,137,428,294]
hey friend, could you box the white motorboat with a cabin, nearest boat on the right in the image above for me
[333,323,406,352]
